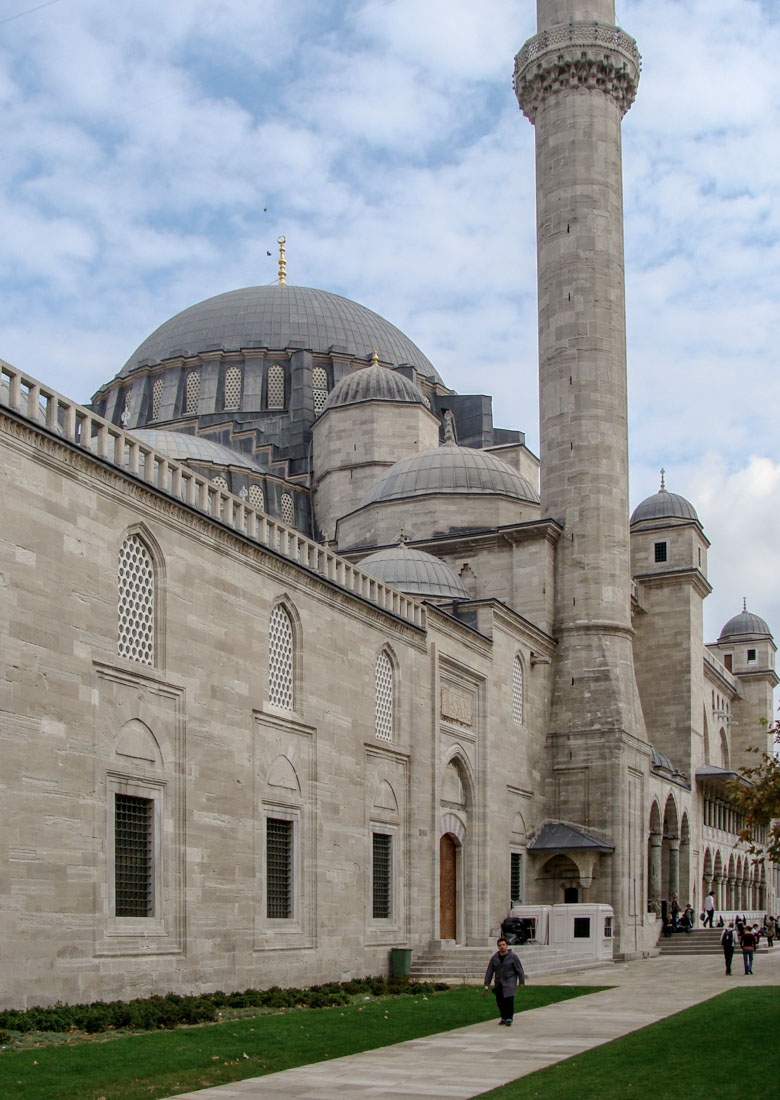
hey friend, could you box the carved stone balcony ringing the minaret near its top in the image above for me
[515,23,641,122]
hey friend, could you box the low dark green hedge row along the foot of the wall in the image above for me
[0,978,447,1034]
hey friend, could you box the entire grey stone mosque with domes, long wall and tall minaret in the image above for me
[0,0,779,1007]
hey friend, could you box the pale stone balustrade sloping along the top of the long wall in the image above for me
[0,360,425,628]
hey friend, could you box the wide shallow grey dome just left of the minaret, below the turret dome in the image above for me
[363,443,539,504]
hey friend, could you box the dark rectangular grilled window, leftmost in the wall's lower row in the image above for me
[114,793,154,916]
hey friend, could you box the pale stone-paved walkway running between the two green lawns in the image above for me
[170,946,780,1100]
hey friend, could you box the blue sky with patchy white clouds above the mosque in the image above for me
[0,0,780,660]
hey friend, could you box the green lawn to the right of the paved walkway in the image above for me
[483,987,780,1100]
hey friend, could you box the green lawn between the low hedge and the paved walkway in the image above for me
[0,986,594,1100]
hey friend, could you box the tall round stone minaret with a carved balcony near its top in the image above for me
[515,0,648,952]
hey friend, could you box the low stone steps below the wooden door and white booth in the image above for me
[409,939,612,986]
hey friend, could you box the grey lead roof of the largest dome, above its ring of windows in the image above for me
[120,284,441,382]
